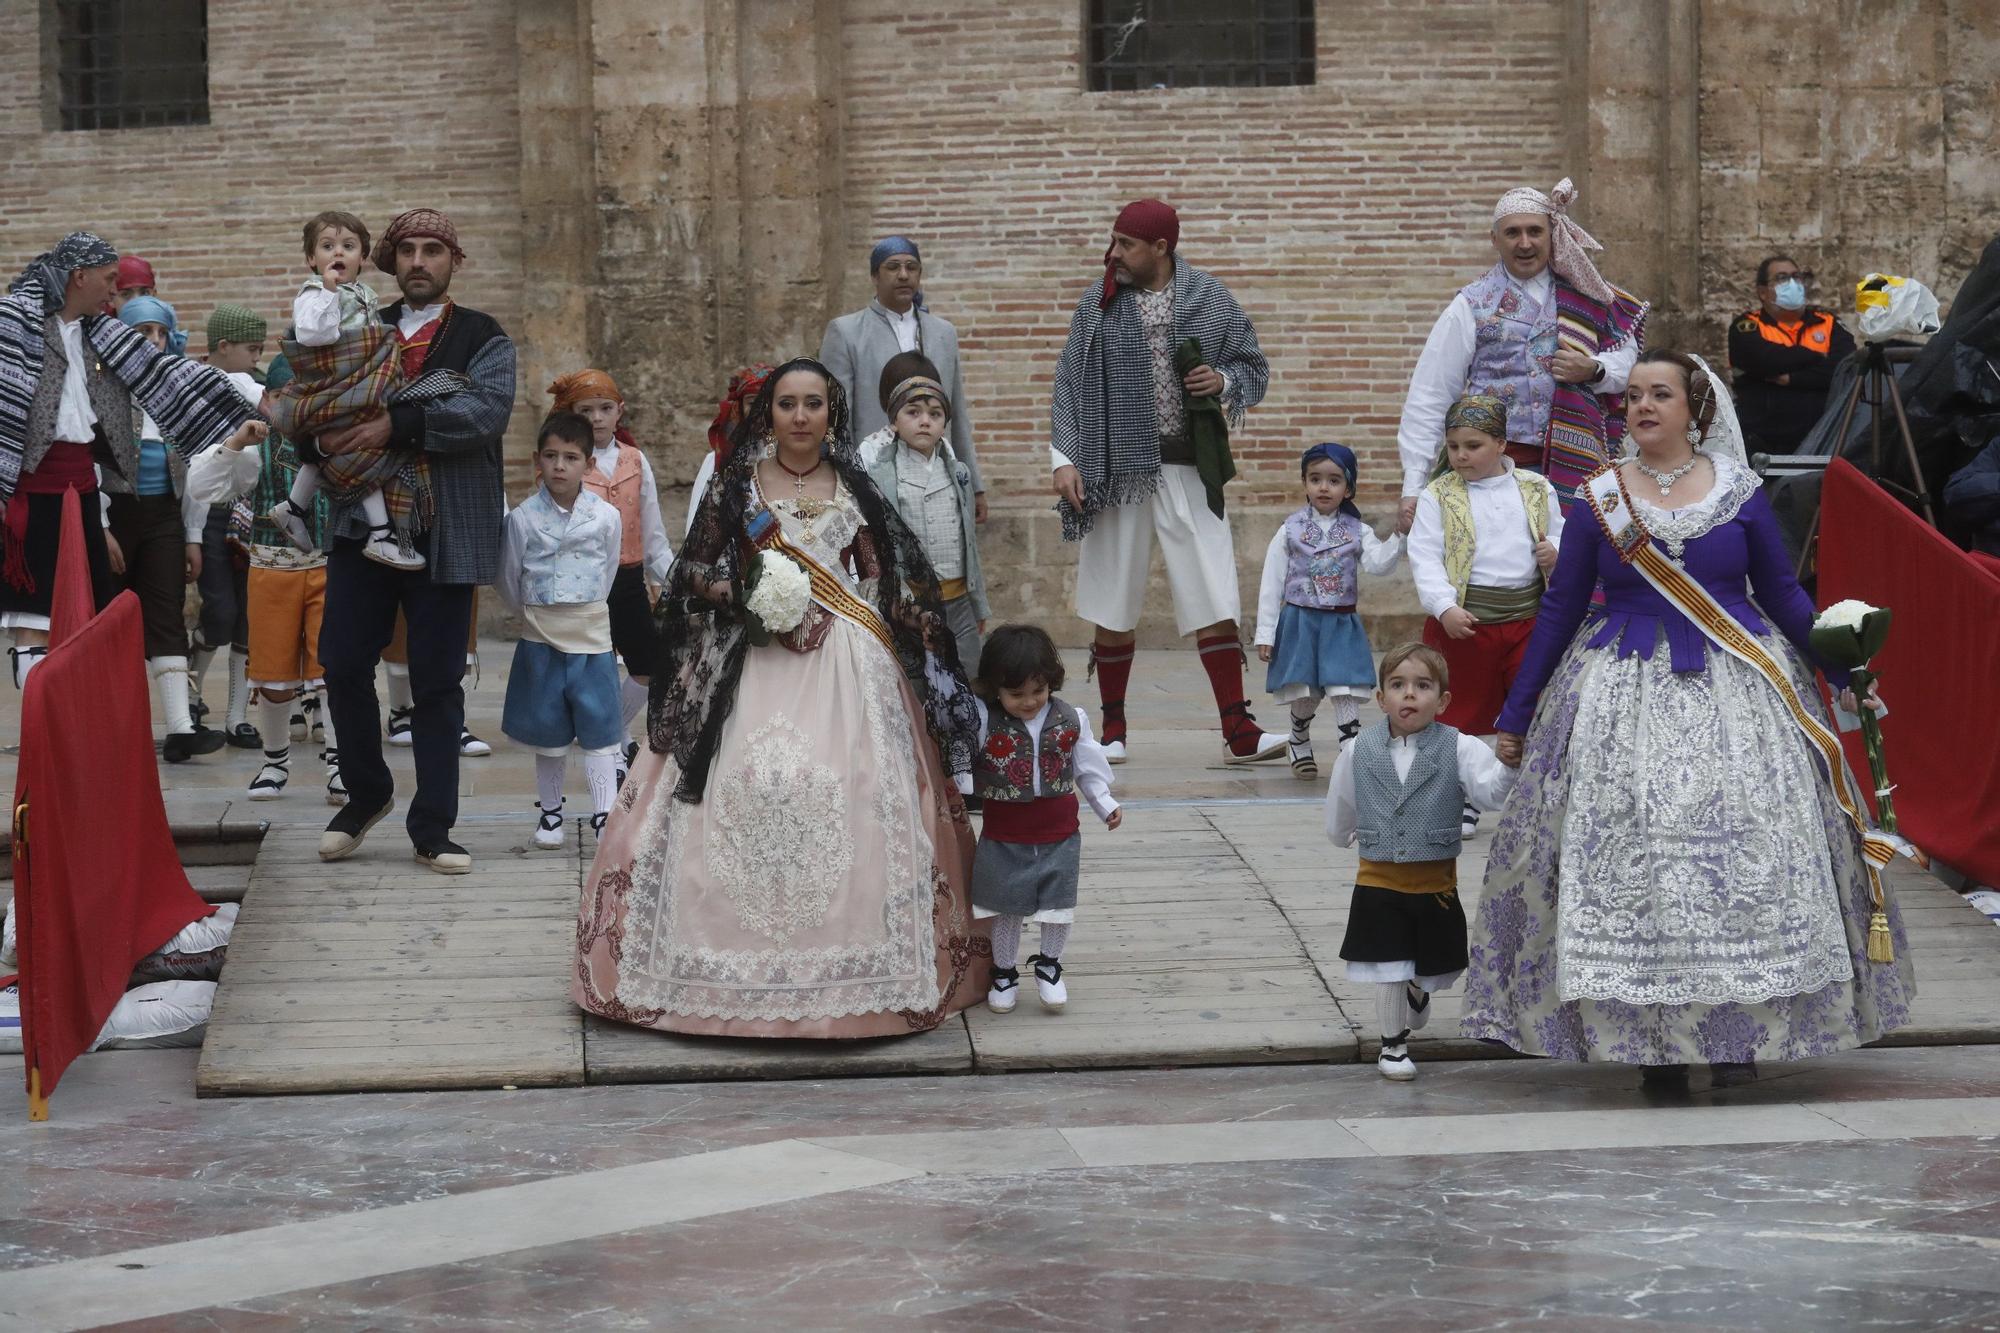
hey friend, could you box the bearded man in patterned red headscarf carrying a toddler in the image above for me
[318,208,514,875]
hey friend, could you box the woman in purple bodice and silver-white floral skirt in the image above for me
[1464,352,1916,1085]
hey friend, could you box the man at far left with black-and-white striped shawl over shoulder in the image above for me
[0,232,262,696]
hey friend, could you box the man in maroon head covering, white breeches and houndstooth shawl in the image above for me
[1050,198,1284,765]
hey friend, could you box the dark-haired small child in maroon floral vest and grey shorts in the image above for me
[972,624,1124,1013]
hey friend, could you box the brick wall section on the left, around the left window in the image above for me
[0,0,520,438]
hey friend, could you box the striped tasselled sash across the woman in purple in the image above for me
[1580,466,1906,963]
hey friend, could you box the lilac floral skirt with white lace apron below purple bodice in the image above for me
[1462,624,1916,1065]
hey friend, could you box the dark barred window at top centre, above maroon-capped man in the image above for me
[1084,0,1314,92]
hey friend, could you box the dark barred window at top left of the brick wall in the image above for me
[44,0,208,130]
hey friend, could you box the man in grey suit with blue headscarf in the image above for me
[820,236,986,522]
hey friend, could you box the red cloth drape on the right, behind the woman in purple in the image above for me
[1820,460,2000,885]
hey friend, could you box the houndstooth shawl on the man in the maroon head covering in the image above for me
[1048,260,1270,542]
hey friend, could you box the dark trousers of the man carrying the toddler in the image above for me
[320,534,472,847]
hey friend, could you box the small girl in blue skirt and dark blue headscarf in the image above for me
[1256,444,1402,779]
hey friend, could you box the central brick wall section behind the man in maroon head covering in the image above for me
[842,0,1576,510]
